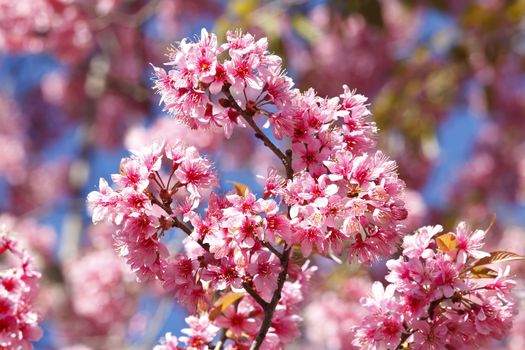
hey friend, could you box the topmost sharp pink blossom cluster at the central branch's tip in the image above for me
[151,29,293,136]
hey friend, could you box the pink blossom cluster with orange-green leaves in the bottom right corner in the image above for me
[353,222,523,349]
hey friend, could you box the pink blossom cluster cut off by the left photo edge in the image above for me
[0,232,42,349]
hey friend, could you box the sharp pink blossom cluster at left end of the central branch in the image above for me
[88,142,217,279]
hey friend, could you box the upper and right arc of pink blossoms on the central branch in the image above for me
[155,29,407,262]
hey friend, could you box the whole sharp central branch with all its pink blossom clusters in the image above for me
[88,30,520,350]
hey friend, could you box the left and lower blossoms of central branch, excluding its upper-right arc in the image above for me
[86,143,315,349]
